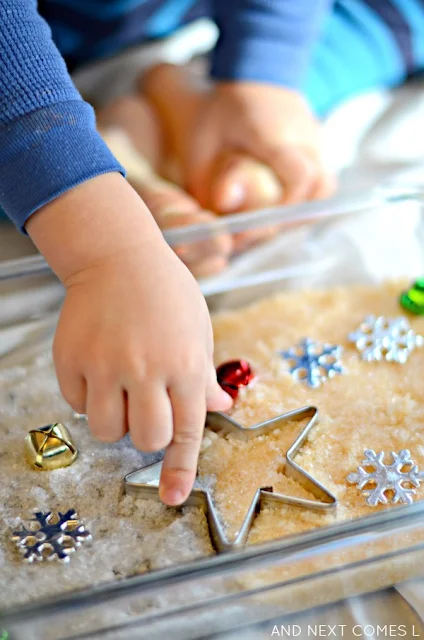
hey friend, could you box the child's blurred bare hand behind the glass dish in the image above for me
[186,82,334,211]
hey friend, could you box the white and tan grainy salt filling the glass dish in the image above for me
[0,282,424,609]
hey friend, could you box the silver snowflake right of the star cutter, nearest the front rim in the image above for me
[347,449,424,507]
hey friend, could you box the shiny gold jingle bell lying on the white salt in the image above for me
[25,422,78,471]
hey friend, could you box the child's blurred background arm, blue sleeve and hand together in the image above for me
[186,0,333,206]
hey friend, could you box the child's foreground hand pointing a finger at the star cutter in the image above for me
[27,174,231,505]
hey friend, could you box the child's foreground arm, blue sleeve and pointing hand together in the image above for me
[0,0,231,504]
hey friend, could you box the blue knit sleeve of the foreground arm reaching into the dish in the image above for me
[0,0,124,229]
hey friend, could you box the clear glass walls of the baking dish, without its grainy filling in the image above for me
[0,187,424,640]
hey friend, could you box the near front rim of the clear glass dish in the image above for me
[0,482,424,625]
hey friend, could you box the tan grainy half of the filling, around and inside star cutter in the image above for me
[207,282,424,543]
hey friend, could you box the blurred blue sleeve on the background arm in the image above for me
[212,0,334,89]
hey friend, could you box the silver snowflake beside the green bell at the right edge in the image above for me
[349,316,424,364]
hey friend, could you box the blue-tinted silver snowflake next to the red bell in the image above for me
[280,338,344,388]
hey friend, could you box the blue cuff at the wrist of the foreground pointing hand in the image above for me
[0,100,125,231]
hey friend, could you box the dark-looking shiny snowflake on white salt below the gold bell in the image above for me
[12,509,91,562]
